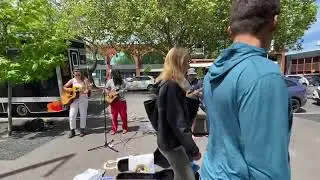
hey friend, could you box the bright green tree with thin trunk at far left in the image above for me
[0,0,75,135]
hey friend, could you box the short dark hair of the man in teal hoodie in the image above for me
[230,0,280,35]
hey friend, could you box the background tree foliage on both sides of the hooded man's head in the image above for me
[60,0,317,58]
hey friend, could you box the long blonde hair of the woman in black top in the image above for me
[156,47,191,89]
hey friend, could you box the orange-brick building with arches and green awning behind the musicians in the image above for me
[85,45,213,86]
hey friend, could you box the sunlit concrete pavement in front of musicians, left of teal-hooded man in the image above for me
[0,121,206,180]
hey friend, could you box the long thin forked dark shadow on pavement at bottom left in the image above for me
[0,153,76,179]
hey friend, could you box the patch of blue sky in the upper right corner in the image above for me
[302,0,320,51]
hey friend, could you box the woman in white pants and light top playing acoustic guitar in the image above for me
[63,68,91,138]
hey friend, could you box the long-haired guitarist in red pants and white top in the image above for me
[105,70,128,135]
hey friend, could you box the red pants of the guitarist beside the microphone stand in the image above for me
[111,101,128,132]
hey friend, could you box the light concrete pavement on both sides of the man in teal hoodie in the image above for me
[0,118,320,180]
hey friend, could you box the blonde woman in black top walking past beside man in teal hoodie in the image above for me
[156,48,201,180]
